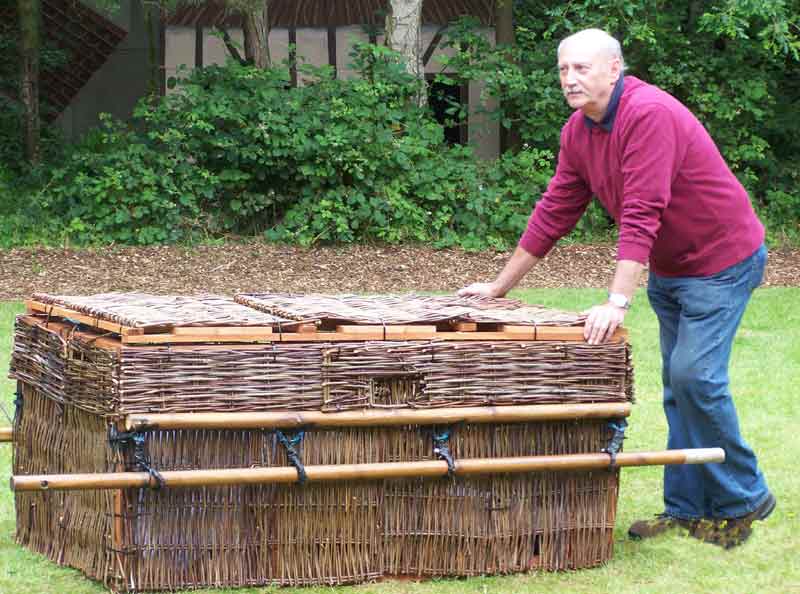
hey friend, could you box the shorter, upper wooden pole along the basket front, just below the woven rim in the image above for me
[125,402,631,431]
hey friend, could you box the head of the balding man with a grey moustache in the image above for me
[558,29,625,121]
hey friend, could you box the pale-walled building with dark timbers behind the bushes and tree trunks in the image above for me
[43,0,499,158]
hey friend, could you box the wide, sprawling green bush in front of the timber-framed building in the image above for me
[37,44,552,249]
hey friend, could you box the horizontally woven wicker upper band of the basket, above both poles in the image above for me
[11,318,633,416]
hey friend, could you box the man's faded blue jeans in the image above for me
[647,245,769,519]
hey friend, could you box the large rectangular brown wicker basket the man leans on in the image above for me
[6,296,632,591]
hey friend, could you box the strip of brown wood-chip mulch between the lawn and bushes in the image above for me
[0,243,800,300]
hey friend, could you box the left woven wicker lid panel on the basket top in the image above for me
[33,293,292,328]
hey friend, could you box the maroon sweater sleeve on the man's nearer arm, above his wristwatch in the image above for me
[617,104,686,264]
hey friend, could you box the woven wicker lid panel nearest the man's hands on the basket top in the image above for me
[234,293,585,326]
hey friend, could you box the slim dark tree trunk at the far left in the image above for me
[17,0,41,164]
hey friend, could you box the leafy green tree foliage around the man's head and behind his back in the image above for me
[442,0,800,238]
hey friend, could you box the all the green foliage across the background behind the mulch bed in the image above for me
[0,0,800,249]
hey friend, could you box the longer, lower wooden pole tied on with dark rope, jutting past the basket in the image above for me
[11,448,725,491]
